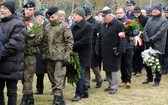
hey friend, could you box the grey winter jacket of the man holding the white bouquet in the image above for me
[143,14,168,54]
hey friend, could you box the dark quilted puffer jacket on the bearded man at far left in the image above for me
[0,14,26,80]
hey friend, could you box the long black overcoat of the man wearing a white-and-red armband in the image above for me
[100,18,125,72]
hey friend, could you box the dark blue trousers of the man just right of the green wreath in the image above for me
[75,67,88,96]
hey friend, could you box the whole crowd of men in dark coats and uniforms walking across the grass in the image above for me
[0,0,168,105]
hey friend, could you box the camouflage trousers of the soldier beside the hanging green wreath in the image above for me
[47,61,66,96]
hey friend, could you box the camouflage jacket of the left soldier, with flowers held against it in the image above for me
[25,17,44,55]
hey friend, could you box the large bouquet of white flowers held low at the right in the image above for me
[142,47,162,72]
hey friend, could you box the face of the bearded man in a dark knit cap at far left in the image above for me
[0,5,12,19]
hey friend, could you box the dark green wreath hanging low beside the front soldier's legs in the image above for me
[66,52,81,85]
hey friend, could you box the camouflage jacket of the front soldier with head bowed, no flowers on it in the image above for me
[45,20,74,61]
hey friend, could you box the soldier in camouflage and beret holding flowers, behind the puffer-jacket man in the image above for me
[21,1,42,105]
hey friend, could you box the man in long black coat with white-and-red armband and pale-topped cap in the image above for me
[97,6,125,94]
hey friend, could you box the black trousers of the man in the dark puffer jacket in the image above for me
[0,79,18,105]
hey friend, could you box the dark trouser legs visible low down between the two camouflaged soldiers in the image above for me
[36,74,44,92]
